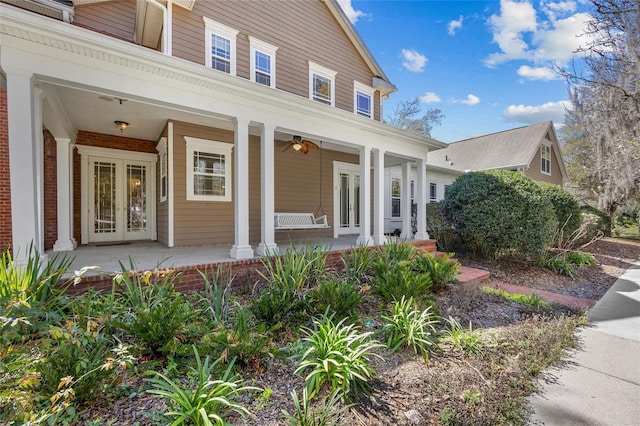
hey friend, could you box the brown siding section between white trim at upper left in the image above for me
[73,0,136,41]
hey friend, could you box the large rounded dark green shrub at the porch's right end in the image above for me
[443,170,556,258]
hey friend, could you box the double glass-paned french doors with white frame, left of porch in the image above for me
[78,145,156,244]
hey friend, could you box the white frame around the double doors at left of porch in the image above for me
[76,145,158,244]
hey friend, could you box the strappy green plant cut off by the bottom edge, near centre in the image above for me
[282,388,351,426]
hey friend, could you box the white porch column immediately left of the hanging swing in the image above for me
[257,124,279,256]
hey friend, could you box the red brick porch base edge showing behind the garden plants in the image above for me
[67,240,436,295]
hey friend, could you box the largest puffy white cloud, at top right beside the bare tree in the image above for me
[484,0,591,67]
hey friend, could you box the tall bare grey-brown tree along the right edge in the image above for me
[562,0,640,220]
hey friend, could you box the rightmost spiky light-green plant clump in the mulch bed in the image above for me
[382,297,440,360]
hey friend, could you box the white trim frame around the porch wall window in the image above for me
[184,136,233,201]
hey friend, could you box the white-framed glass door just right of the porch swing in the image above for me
[333,161,360,236]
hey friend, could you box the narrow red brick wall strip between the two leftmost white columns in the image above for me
[43,130,58,250]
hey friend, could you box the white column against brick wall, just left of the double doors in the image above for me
[53,138,76,251]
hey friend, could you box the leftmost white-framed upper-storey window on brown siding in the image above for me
[202,17,238,75]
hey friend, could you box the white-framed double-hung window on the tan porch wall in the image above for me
[184,136,233,201]
